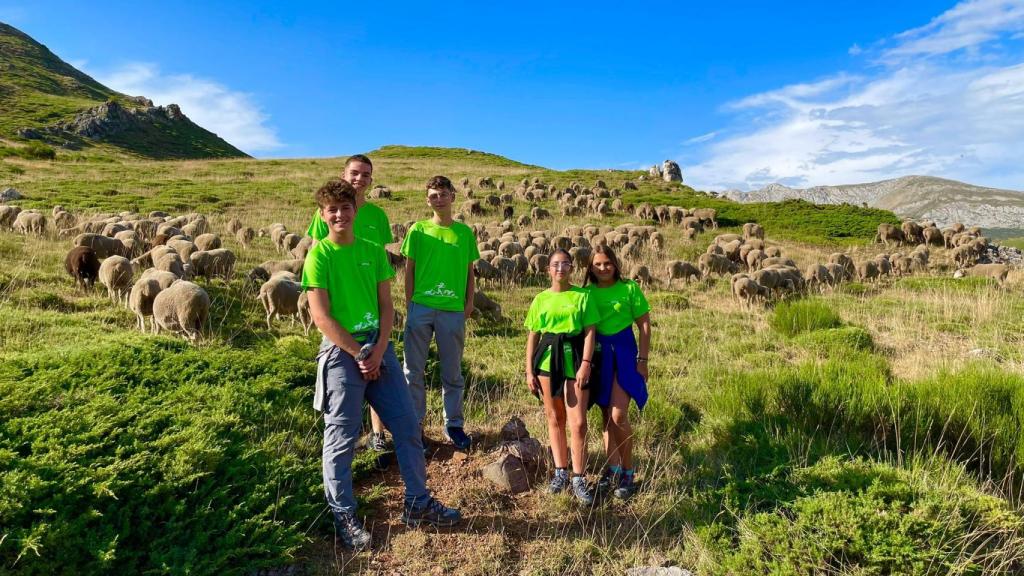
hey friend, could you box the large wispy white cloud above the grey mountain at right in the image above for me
[684,0,1024,190]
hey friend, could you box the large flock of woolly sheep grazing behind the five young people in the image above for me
[0,178,1009,339]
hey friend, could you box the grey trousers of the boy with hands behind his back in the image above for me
[403,302,466,427]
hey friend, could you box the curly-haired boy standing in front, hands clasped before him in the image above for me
[302,180,461,549]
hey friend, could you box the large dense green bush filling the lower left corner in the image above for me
[0,335,323,575]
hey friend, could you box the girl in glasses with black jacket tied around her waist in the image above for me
[525,249,599,505]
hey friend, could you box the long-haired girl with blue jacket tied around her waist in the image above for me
[584,245,650,499]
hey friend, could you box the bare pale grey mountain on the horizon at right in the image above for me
[723,176,1024,229]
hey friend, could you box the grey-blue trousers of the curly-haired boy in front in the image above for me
[314,338,430,516]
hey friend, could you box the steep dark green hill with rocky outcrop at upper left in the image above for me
[0,23,248,159]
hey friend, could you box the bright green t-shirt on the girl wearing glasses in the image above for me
[523,286,600,370]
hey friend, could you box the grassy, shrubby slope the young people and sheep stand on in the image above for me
[0,147,1024,575]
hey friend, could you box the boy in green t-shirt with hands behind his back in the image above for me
[401,176,480,450]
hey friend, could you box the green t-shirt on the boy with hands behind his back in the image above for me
[401,220,480,312]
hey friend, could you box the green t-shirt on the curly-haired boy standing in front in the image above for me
[302,238,394,334]
